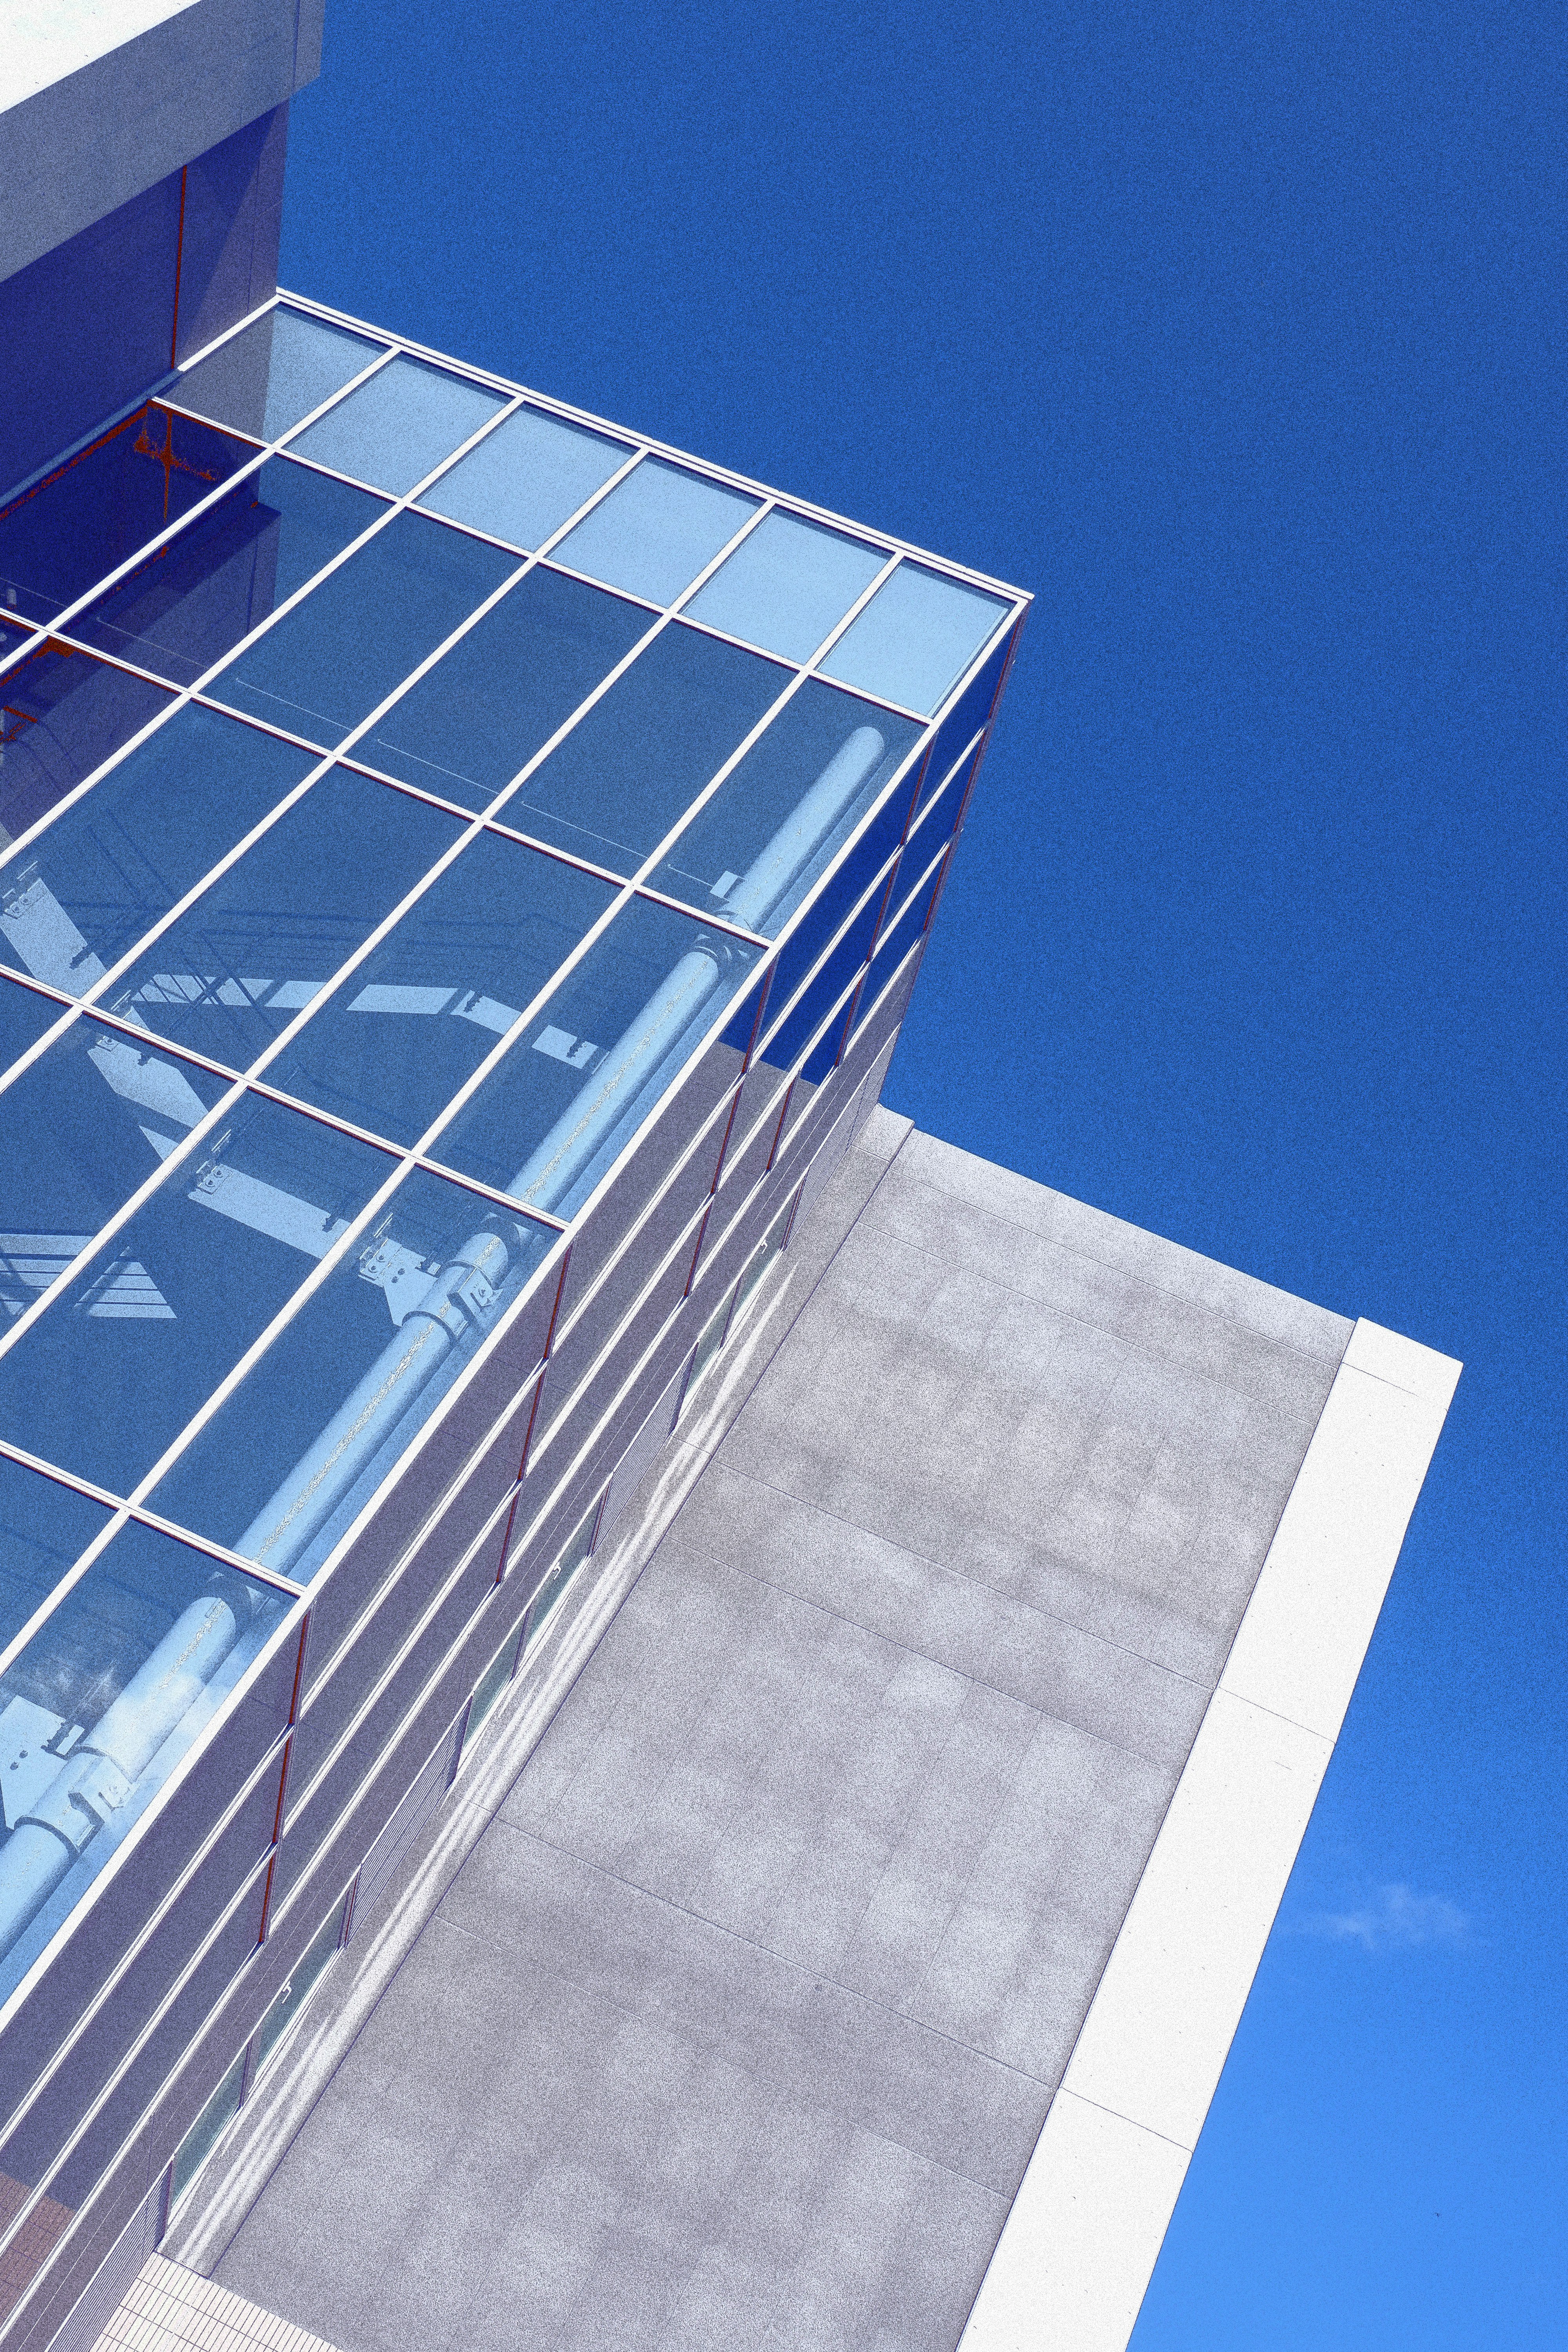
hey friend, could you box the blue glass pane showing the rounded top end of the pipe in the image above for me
[651,673,919,938]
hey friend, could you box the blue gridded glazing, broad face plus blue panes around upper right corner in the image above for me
[0,285,1023,1994]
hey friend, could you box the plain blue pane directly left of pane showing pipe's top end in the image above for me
[498,621,790,896]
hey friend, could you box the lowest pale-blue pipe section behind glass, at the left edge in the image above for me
[0,1592,242,1955]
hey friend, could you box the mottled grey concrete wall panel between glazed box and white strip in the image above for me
[216,1112,1352,2352]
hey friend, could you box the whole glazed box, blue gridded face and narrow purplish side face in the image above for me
[0,285,1025,2340]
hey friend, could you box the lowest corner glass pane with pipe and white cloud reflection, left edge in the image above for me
[0,1524,292,1992]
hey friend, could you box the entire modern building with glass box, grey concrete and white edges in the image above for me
[0,0,1455,2352]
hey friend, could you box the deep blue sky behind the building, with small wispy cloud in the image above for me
[285,0,1568,2352]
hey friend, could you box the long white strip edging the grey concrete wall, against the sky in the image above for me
[959,1322,1460,2352]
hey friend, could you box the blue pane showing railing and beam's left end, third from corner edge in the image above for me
[111,767,463,1070]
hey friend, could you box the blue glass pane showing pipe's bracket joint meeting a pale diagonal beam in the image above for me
[155,1169,557,1578]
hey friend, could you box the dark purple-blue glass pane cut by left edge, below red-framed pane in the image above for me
[0,637,169,849]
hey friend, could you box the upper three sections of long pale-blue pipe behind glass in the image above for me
[221,727,886,1573]
